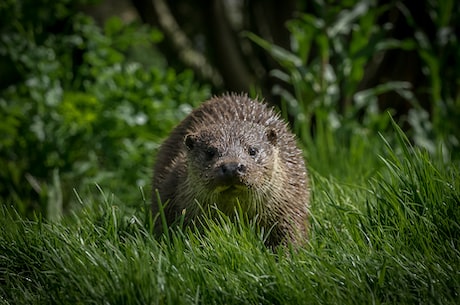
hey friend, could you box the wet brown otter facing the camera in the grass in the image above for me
[152,93,310,246]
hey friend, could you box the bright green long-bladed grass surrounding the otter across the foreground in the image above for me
[0,124,460,304]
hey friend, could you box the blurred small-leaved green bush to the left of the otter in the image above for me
[0,1,209,217]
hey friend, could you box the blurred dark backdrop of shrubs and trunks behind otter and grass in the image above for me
[0,0,460,219]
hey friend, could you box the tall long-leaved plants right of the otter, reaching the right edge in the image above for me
[246,1,460,158]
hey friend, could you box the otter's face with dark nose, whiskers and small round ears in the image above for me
[184,122,277,197]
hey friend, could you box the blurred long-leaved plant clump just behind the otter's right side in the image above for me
[247,1,398,138]
